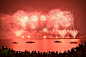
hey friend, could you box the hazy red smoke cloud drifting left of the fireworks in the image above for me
[0,12,16,38]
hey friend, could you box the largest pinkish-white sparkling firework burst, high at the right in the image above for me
[48,9,74,29]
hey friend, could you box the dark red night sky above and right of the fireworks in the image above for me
[0,0,86,38]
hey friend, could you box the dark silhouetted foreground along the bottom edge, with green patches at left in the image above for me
[0,42,86,57]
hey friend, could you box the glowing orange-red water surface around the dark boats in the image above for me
[0,39,85,52]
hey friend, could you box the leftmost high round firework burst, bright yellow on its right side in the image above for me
[13,10,29,29]
